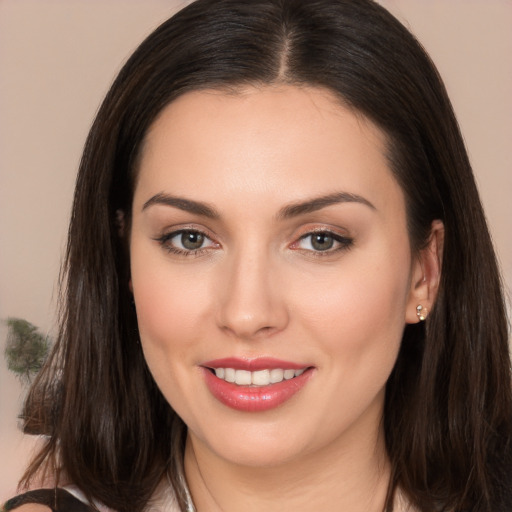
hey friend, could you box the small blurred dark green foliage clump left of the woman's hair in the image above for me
[5,317,51,384]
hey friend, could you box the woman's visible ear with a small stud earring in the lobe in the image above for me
[405,220,444,324]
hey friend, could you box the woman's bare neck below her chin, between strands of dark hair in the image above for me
[185,418,390,512]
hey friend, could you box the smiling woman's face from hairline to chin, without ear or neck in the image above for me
[130,86,421,466]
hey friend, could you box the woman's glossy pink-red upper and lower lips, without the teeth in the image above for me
[201,358,314,412]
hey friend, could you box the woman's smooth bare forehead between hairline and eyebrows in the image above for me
[135,86,401,216]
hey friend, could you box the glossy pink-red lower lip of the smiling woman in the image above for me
[203,368,313,412]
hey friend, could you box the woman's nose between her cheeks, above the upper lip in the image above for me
[218,251,289,340]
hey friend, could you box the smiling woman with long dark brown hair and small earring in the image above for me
[8,0,512,512]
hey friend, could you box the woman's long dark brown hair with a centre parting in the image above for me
[21,0,512,512]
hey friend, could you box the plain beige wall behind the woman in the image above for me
[0,0,512,501]
